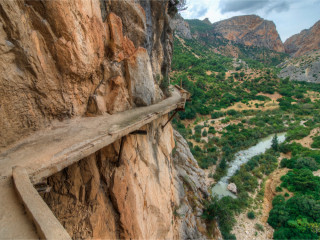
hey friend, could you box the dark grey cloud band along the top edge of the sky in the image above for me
[219,0,290,14]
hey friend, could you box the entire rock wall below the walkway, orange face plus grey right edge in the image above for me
[44,118,208,239]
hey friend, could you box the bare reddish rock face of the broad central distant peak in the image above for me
[212,15,284,52]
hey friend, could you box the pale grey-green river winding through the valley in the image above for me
[212,133,286,198]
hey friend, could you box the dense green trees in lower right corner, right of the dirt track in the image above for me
[268,143,320,239]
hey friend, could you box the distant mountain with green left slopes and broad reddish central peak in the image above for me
[170,15,287,66]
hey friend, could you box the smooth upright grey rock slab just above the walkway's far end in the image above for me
[126,48,155,106]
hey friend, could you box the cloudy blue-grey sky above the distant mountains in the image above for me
[181,0,320,42]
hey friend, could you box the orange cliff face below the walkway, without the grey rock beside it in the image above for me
[44,119,177,239]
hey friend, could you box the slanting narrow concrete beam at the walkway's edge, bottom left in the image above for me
[12,167,71,240]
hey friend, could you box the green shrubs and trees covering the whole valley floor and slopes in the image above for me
[170,25,320,239]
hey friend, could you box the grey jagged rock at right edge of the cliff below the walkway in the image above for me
[173,131,208,239]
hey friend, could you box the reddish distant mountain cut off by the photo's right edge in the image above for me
[284,20,320,57]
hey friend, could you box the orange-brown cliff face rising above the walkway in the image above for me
[0,0,172,147]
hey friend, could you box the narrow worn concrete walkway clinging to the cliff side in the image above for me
[0,86,185,239]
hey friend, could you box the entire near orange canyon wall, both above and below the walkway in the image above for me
[0,0,208,239]
